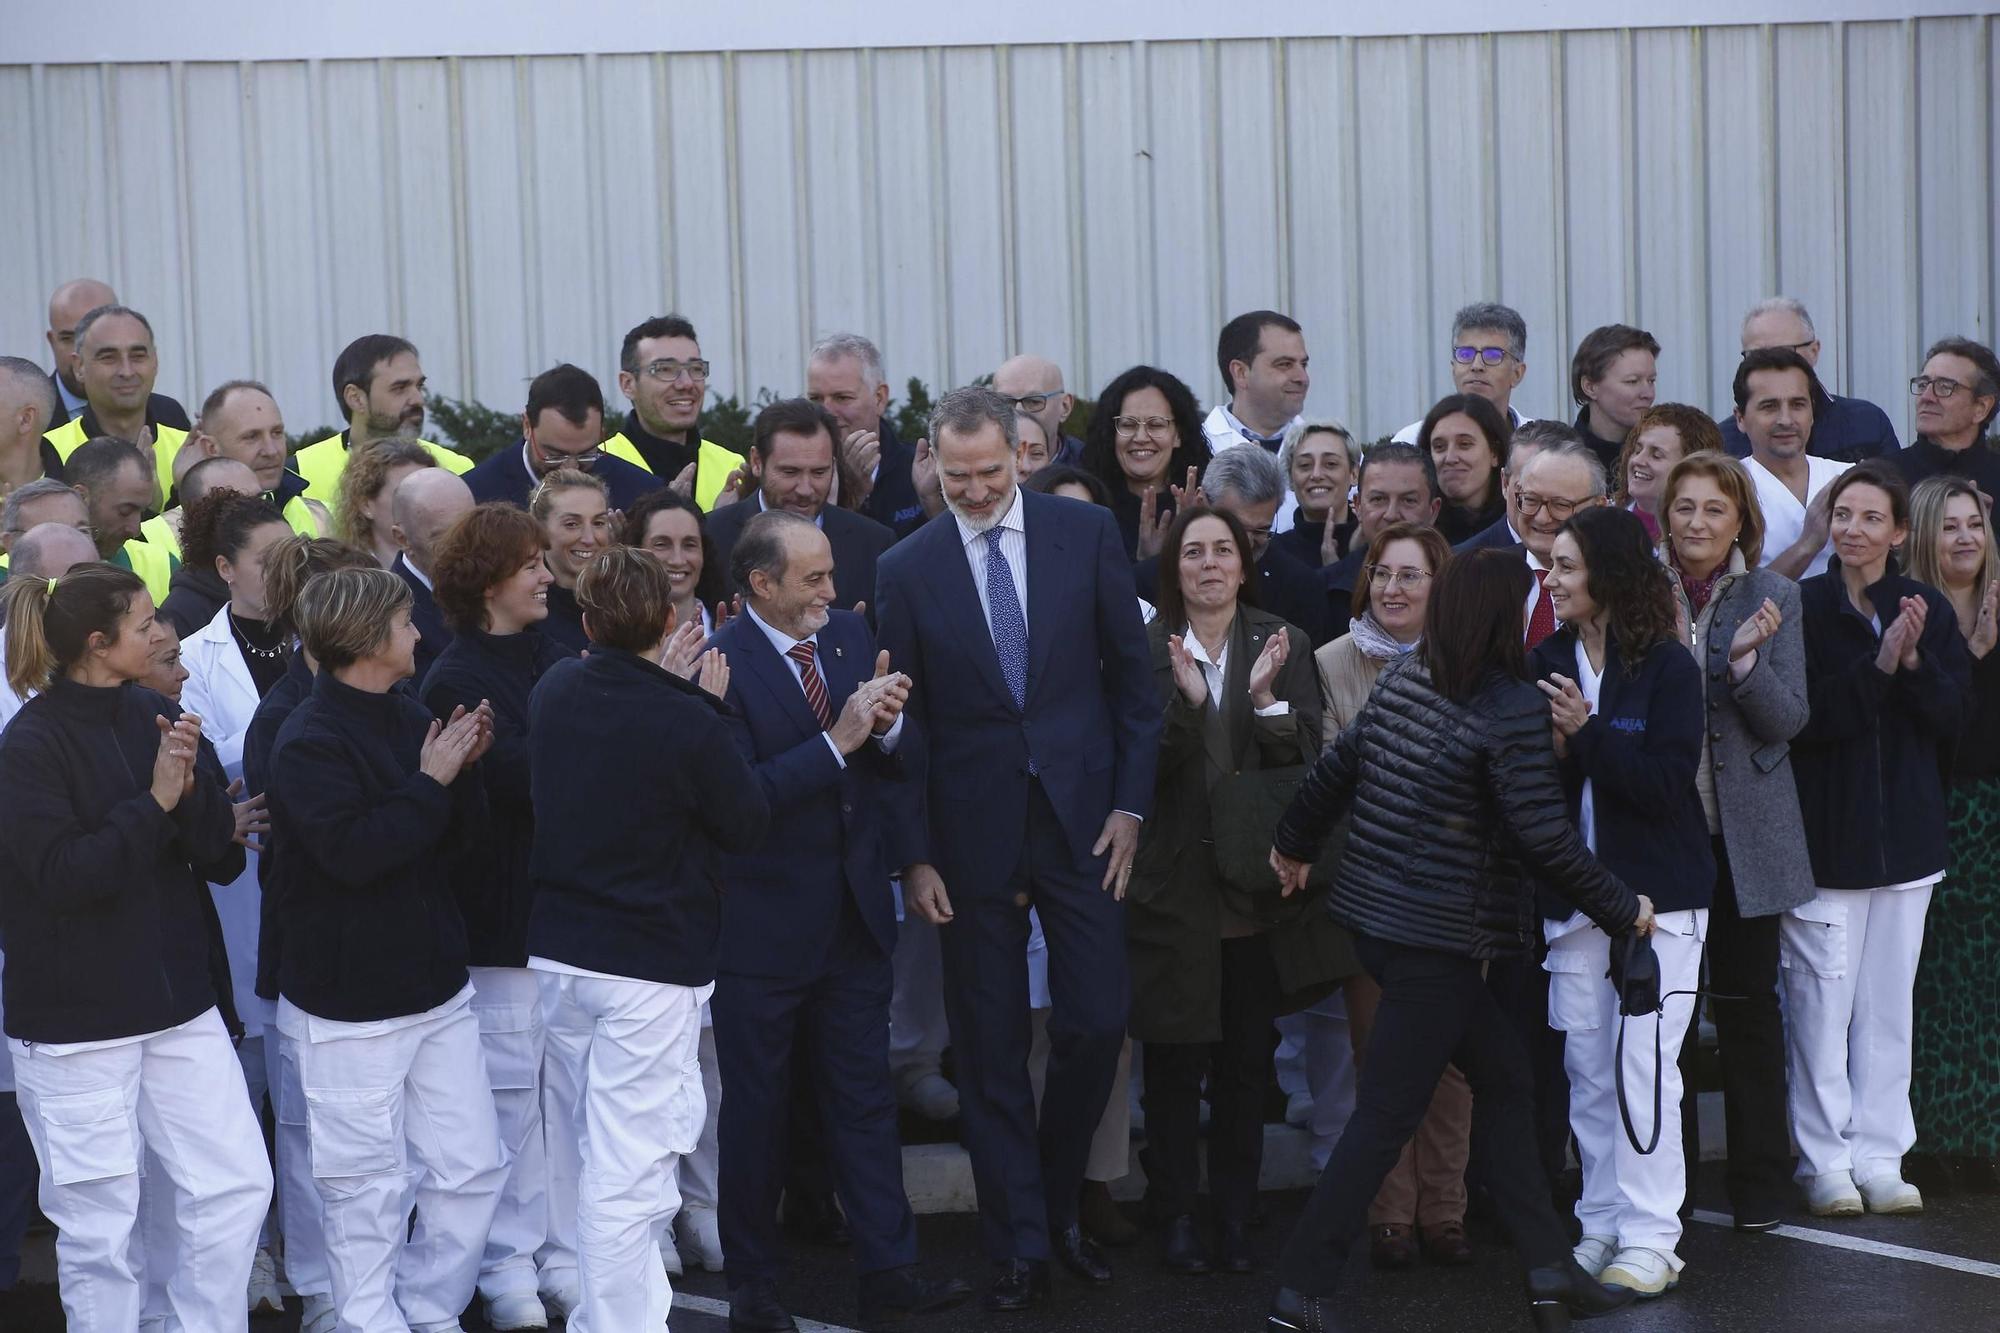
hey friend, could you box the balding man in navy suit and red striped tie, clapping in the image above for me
[710,510,970,1333]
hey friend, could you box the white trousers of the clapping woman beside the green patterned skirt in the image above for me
[1778,885,1930,1185]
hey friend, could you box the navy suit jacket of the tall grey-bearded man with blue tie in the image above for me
[874,490,1162,891]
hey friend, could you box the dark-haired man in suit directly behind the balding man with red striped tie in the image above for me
[708,398,896,610]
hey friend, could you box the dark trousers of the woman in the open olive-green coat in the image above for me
[1144,935,1280,1223]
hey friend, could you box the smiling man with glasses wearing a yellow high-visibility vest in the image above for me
[604,314,750,510]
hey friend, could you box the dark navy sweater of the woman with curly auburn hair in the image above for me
[422,624,576,967]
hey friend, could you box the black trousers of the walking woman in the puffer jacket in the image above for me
[1280,935,1570,1295]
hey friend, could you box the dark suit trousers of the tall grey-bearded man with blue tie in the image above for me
[938,783,1132,1261]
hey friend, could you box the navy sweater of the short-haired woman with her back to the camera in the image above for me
[528,646,770,987]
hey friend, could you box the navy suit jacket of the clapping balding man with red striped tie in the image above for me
[708,610,908,979]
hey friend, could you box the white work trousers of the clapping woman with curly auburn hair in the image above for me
[472,967,548,1301]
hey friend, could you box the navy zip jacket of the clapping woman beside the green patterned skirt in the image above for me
[1792,560,1972,889]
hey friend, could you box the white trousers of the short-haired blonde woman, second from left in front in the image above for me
[278,985,506,1333]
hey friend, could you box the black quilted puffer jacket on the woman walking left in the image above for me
[1276,652,1638,959]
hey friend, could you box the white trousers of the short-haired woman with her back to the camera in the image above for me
[542,973,714,1333]
